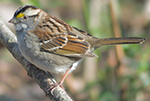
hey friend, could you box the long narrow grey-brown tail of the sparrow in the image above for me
[94,37,145,49]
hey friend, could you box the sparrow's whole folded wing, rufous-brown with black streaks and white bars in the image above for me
[33,17,96,57]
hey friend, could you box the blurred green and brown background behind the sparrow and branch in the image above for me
[0,0,150,101]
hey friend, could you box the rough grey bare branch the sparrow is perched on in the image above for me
[0,18,72,101]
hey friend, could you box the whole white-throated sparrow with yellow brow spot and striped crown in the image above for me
[9,5,145,89]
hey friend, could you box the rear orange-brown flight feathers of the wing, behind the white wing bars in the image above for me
[49,32,97,57]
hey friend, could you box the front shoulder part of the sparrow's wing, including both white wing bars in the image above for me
[32,25,68,51]
